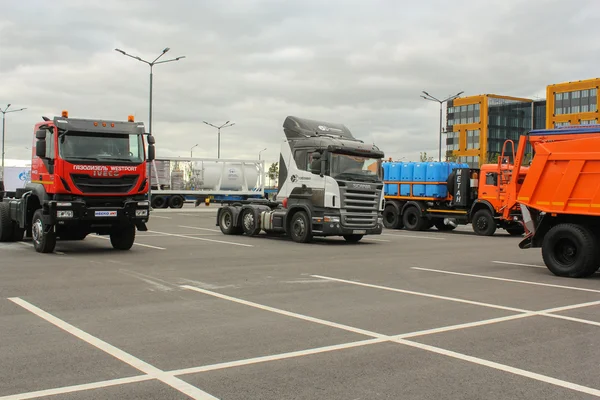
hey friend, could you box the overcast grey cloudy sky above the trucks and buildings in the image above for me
[0,0,600,166]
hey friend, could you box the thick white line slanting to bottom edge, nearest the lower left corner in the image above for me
[9,297,216,400]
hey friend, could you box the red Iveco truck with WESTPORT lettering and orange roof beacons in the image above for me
[0,111,155,253]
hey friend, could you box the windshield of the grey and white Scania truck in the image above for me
[331,153,381,182]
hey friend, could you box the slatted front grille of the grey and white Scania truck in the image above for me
[340,186,381,228]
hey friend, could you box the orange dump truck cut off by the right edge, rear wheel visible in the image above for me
[504,125,600,278]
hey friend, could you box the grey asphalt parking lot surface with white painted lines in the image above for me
[0,206,600,400]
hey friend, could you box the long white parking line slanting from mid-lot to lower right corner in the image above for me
[180,285,600,397]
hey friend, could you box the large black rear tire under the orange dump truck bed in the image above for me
[542,224,600,278]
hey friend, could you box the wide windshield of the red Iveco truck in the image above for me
[59,131,144,163]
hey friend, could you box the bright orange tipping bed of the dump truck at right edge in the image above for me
[517,127,600,216]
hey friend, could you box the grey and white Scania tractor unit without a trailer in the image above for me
[217,116,384,243]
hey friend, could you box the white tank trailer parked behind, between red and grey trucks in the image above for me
[149,157,265,208]
